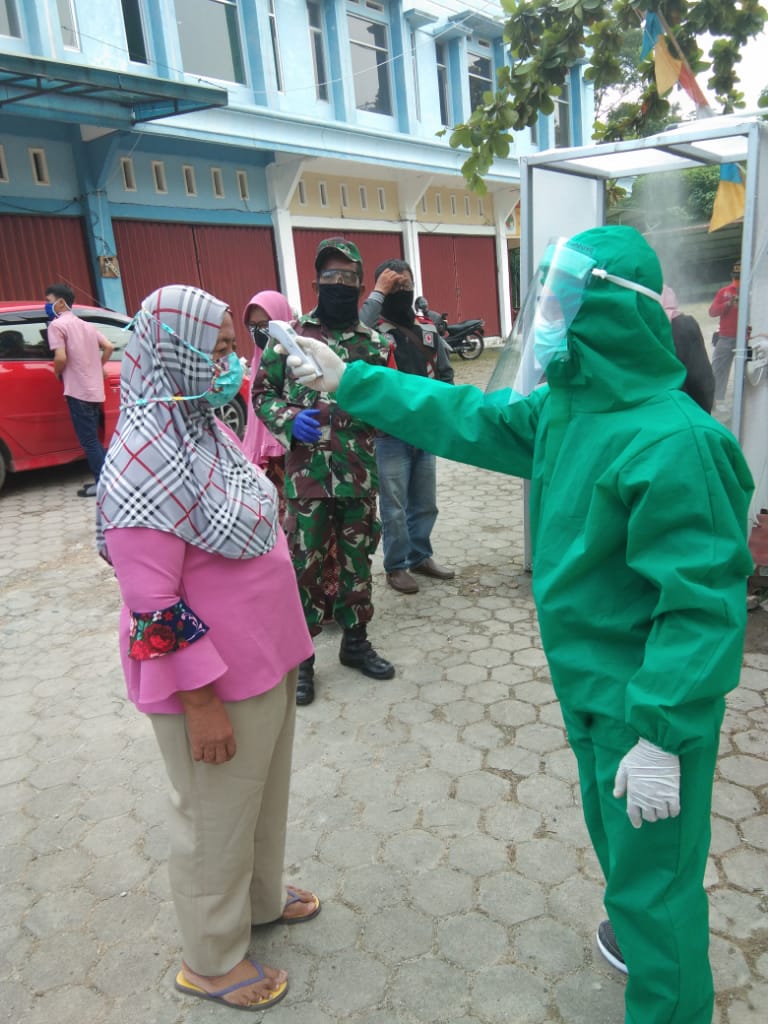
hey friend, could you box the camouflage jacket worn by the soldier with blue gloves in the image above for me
[251,313,389,498]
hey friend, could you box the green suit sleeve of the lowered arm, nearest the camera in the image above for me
[618,423,752,754]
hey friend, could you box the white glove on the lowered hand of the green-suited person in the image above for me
[613,739,680,828]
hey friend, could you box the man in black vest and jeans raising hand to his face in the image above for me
[360,259,456,594]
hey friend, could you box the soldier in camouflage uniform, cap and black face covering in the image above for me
[252,239,394,705]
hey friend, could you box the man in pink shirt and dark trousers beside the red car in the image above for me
[45,285,114,498]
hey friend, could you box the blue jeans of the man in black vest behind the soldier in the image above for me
[376,436,437,572]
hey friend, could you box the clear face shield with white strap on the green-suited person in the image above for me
[485,239,662,402]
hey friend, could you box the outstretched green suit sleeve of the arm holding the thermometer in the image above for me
[336,362,547,478]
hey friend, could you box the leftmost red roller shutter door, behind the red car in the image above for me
[0,214,99,305]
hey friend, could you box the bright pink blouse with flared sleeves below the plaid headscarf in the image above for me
[105,527,312,714]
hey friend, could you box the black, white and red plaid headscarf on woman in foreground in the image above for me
[96,285,278,558]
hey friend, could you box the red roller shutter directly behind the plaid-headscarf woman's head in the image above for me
[114,220,279,357]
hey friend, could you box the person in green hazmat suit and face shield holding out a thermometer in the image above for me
[280,226,753,1024]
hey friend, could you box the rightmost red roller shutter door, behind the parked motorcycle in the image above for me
[419,234,501,335]
